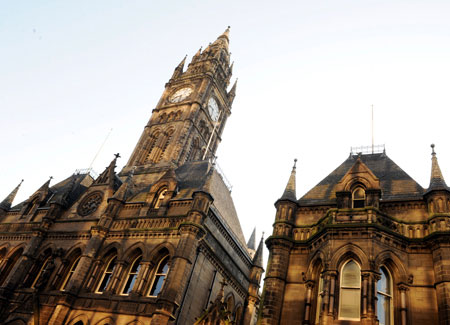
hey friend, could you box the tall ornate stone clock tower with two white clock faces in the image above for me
[121,28,236,178]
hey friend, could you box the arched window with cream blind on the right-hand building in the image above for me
[339,260,361,320]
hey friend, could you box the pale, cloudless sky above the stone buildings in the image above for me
[0,0,450,258]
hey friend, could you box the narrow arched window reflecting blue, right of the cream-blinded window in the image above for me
[377,266,393,325]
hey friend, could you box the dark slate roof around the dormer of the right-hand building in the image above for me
[298,153,424,205]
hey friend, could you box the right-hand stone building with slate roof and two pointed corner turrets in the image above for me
[258,146,450,325]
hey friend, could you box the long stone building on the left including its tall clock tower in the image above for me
[0,30,263,325]
